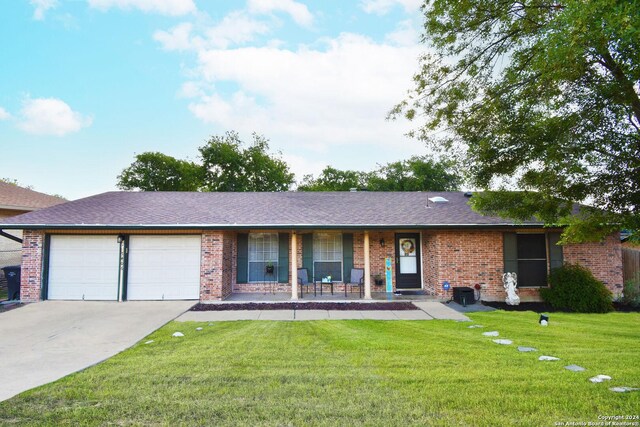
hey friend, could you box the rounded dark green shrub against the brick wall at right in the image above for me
[540,264,613,313]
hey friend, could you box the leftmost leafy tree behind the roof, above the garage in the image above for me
[118,152,203,191]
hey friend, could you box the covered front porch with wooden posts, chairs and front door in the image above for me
[228,228,428,301]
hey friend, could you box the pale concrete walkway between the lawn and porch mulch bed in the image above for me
[176,301,469,322]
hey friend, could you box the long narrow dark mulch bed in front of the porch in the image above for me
[191,302,419,311]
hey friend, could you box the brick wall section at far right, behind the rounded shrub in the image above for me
[562,233,623,296]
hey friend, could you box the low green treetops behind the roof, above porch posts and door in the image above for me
[298,156,461,191]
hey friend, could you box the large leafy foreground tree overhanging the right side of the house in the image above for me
[391,0,640,241]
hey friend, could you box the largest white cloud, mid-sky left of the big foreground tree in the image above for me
[189,34,420,153]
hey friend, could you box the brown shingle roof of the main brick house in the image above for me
[0,192,542,229]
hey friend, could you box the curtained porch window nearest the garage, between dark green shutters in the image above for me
[249,233,278,282]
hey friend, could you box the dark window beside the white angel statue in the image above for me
[518,234,547,287]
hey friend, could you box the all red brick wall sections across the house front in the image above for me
[21,230,623,301]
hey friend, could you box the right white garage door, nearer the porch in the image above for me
[127,235,201,300]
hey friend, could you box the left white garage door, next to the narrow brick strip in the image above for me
[47,236,120,300]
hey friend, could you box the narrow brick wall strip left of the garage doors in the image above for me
[20,230,44,302]
